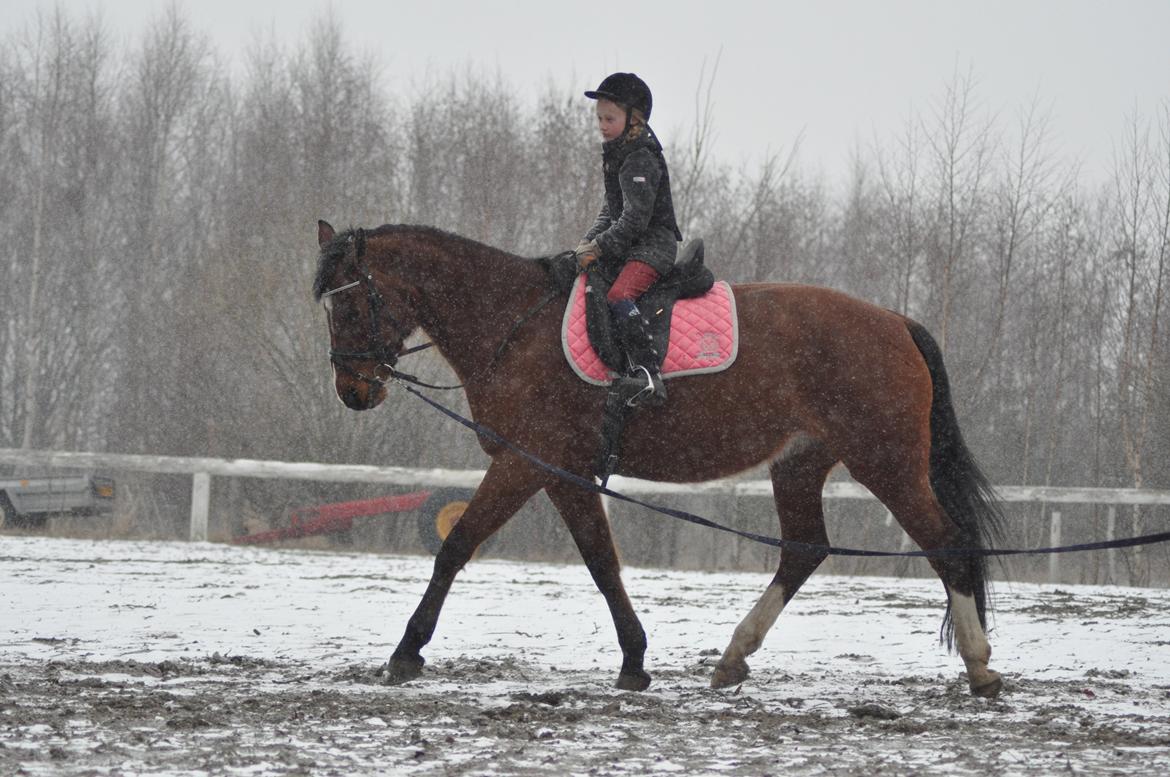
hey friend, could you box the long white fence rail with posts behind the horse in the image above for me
[0,448,1170,579]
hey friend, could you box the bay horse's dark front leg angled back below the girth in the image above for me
[545,482,651,690]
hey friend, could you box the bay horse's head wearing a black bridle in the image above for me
[312,221,418,410]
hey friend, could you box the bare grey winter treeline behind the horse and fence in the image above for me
[0,6,1170,580]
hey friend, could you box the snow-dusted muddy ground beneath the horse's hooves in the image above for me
[0,536,1170,776]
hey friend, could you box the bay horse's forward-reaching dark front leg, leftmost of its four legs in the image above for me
[386,454,543,683]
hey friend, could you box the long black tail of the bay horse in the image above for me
[907,321,1004,647]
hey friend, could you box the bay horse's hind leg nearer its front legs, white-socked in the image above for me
[711,435,837,688]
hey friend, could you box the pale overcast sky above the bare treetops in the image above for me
[9,0,1170,179]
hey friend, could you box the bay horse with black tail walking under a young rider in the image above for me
[314,221,1003,697]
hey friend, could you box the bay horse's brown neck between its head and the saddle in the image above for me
[388,234,546,380]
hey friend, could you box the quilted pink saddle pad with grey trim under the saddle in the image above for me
[560,275,739,386]
